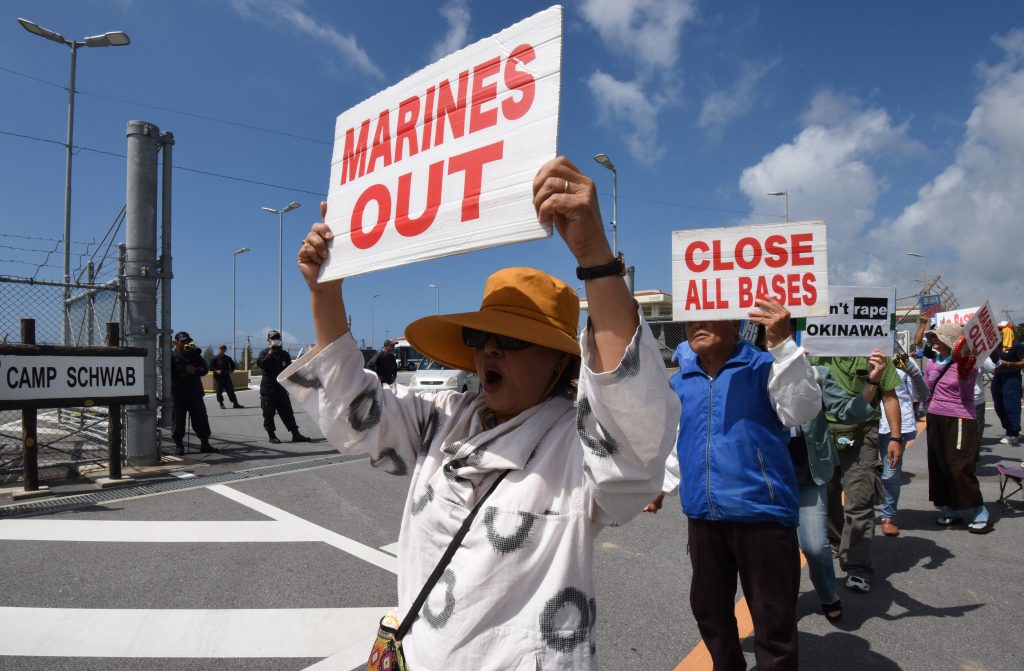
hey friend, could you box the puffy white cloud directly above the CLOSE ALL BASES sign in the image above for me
[739,90,918,285]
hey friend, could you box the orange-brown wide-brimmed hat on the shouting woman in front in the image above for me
[406,267,580,372]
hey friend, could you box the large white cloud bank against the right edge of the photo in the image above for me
[865,30,1024,309]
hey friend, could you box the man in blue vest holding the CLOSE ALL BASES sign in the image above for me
[671,299,821,670]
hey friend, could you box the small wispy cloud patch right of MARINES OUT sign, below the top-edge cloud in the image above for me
[587,70,665,163]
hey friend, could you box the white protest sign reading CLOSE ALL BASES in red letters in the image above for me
[672,221,828,322]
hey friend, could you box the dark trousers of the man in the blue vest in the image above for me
[687,519,800,671]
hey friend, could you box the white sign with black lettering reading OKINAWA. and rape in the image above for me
[800,286,896,357]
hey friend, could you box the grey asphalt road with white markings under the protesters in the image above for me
[0,391,1024,671]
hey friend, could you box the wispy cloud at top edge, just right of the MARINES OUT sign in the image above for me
[580,0,696,163]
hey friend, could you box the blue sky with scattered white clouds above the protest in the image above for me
[0,0,1024,354]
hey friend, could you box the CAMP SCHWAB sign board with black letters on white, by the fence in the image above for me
[0,354,145,402]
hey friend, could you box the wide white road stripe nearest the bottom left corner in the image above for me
[0,606,389,669]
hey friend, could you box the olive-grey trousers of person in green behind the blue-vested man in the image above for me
[828,426,883,578]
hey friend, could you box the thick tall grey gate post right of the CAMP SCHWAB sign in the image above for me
[123,121,160,466]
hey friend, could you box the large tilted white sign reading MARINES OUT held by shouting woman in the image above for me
[319,6,562,282]
